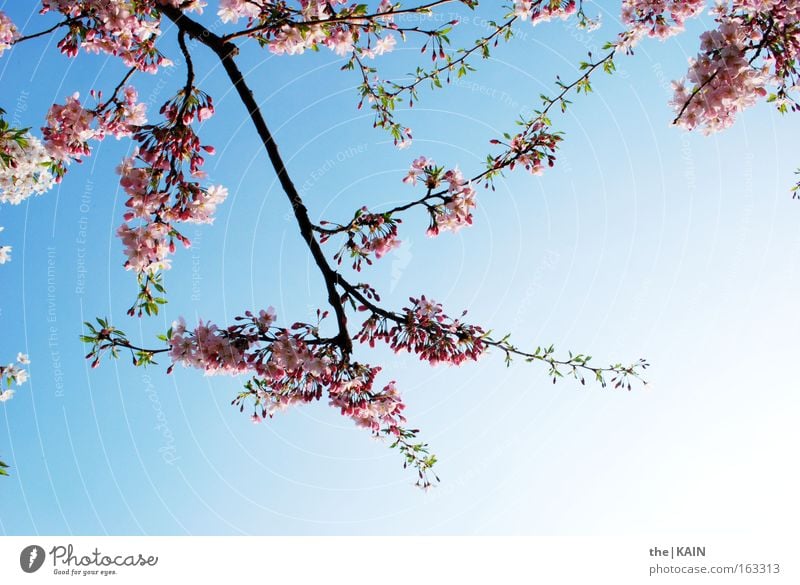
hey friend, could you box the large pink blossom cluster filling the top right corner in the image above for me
[671,0,800,133]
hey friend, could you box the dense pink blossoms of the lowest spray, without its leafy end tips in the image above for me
[166,307,412,434]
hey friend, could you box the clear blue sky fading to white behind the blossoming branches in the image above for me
[0,0,800,535]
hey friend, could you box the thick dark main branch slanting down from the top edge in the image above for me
[159,5,353,358]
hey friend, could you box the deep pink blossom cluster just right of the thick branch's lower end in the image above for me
[356,295,487,365]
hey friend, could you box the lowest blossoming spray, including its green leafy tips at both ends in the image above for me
[84,299,444,487]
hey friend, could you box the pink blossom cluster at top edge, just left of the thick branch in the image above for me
[42,0,173,73]
